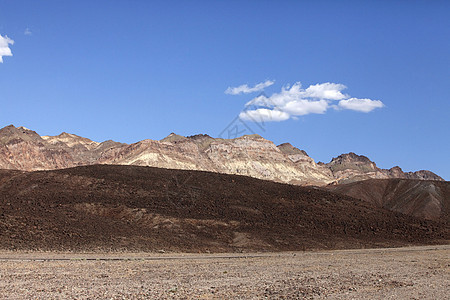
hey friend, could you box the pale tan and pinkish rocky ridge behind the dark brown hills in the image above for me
[0,125,443,186]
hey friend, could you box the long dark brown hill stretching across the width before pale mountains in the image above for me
[0,165,449,251]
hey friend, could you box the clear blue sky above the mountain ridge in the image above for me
[0,0,450,180]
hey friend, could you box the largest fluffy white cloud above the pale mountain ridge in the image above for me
[240,82,384,122]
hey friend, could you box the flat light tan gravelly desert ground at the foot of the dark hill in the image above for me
[0,245,450,299]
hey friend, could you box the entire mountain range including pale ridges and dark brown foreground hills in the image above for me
[0,125,450,252]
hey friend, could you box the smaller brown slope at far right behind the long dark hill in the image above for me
[328,179,450,222]
